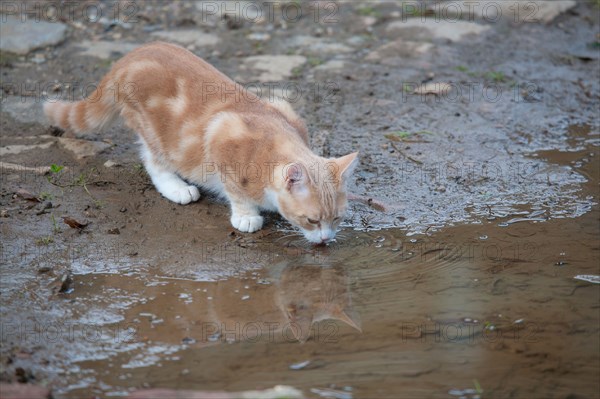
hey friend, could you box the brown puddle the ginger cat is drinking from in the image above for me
[5,199,598,398]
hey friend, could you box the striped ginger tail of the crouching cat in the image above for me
[44,79,120,133]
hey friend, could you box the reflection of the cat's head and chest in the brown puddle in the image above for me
[201,264,360,342]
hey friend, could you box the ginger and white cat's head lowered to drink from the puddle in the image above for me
[277,152,358,244]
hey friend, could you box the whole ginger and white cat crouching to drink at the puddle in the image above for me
[44,42,357,243]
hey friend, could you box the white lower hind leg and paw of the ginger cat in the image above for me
[142,140,200,205]
